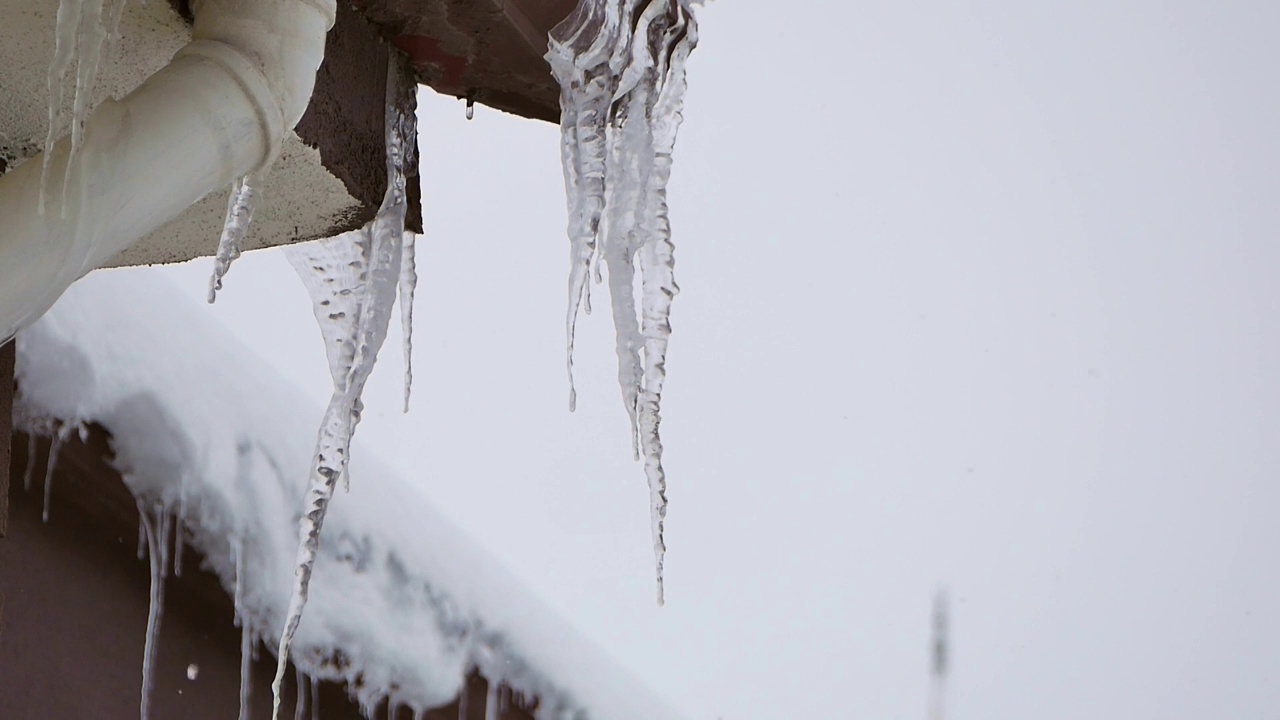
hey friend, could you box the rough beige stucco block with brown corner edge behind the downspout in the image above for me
[0,0,421,265]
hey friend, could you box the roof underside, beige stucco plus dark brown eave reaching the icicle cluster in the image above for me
[0,0,586,265]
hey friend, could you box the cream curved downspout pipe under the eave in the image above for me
[0,0,337,343]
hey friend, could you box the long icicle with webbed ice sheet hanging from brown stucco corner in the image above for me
[271,55,416,720]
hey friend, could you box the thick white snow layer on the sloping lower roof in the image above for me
[17,269,677,720]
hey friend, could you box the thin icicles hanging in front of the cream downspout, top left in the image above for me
[40,0,127,214]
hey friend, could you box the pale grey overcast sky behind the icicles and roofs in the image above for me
[152,0,1280,720]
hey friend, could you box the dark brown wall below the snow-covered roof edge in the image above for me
[0,425,531,720]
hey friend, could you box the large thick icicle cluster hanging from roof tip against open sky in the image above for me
[547,0,698,605]
